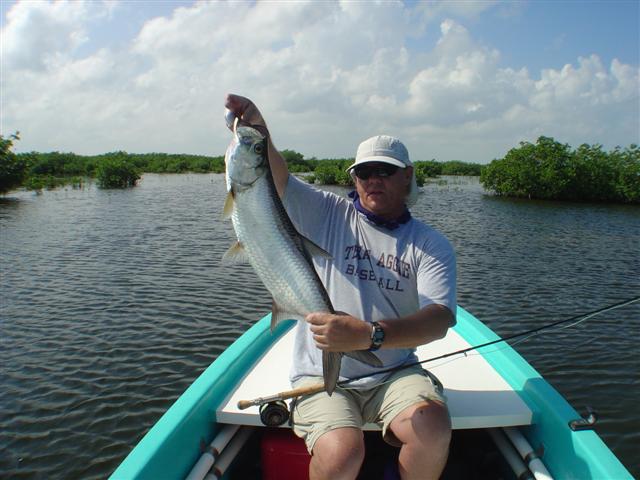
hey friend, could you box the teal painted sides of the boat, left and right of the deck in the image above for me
[110,307,632,480]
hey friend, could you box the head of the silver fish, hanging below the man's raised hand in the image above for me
[225,122,269,191]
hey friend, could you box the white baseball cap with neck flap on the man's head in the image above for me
[347,135,418,205]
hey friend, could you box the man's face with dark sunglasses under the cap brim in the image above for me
[355,162,413,220]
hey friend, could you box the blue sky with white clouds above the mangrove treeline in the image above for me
[0,0,640,163]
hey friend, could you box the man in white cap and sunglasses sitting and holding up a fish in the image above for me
[226,95,456,479]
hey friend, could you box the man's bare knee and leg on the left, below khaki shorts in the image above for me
[309,428,364,480]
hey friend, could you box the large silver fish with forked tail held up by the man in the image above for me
[222,111,382,395]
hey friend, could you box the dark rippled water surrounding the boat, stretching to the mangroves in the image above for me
[0,174,640,479]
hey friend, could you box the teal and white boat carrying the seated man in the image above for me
[110,307,633,480]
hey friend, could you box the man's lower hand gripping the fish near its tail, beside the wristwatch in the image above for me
[305,312,371,352]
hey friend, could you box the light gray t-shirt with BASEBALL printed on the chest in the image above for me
[284,175,456,388]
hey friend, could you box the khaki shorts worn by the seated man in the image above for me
[291,365,446,453]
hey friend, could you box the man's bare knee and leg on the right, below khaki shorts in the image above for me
[389,400,451,480]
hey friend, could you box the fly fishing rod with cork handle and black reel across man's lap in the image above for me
[238,297,640,416]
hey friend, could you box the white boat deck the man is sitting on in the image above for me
[216,328,532,430]
